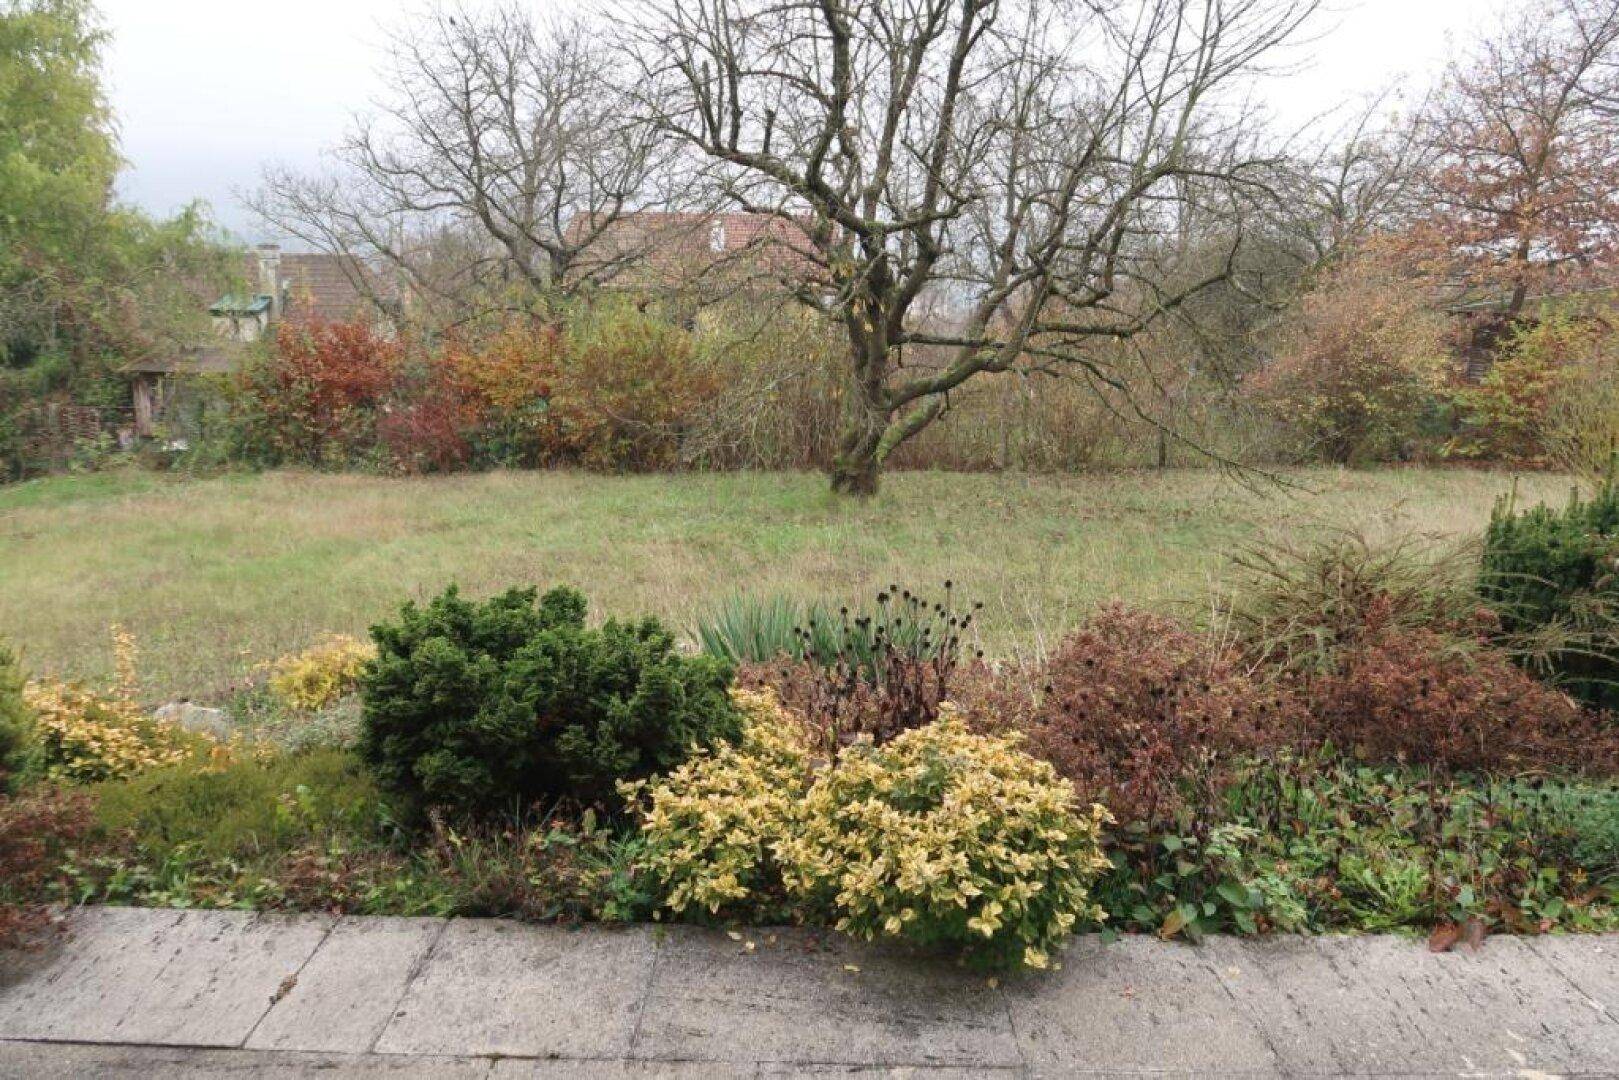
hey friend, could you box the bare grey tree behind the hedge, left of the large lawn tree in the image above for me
[249,6,670,325]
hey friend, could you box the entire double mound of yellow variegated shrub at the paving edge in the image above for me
[643,691,1107,968]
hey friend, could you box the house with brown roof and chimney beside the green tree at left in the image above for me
[125,244,387,439]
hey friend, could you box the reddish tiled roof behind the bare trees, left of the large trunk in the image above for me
[567,210,821,288]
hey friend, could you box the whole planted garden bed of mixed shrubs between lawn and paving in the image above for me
[0,472,1619,968]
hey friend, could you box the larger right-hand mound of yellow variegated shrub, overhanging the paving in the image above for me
[776,706,1109,968]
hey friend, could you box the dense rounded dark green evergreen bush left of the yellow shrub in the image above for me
[359,586,740,814]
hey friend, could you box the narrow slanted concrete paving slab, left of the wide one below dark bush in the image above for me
[246,918,447,1054]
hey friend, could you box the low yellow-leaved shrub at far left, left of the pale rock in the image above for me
[23,680,210,784]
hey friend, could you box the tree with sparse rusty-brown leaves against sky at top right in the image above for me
[1415,0,1619,316]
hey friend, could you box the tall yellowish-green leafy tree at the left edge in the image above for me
[0,0,220,478]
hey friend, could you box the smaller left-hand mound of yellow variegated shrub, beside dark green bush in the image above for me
[620,690,810,915]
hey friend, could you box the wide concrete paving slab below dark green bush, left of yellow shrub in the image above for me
[376,920,652,1059]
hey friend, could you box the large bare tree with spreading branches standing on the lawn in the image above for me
[633,0,1315,494]
